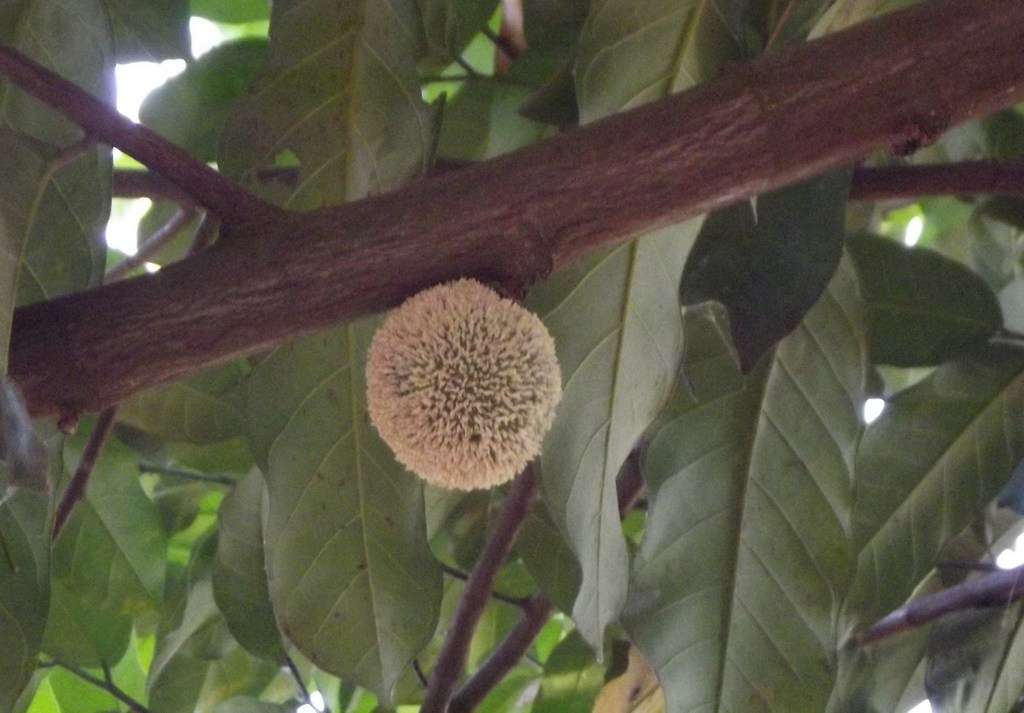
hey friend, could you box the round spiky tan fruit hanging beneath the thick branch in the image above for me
[367,280,562,490]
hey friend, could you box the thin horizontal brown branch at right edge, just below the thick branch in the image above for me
[850,161,1024,201]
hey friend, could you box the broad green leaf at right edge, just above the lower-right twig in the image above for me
[846,350,1024,627]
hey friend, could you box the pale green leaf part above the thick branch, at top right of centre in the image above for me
[575,0,743,123]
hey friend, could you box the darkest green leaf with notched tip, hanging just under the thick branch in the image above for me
[680,170,850,371]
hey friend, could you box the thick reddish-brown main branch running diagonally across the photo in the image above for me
[6,0,1024,416]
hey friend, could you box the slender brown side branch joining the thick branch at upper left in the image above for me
[0,46,280,224]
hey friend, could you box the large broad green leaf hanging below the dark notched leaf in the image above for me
[624,260,867,713]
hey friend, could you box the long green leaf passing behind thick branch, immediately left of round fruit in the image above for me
[221,0,441,701]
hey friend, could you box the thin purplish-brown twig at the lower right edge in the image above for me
[855,568,1024,644]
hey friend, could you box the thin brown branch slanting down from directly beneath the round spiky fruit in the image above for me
[420,465,537,713]
